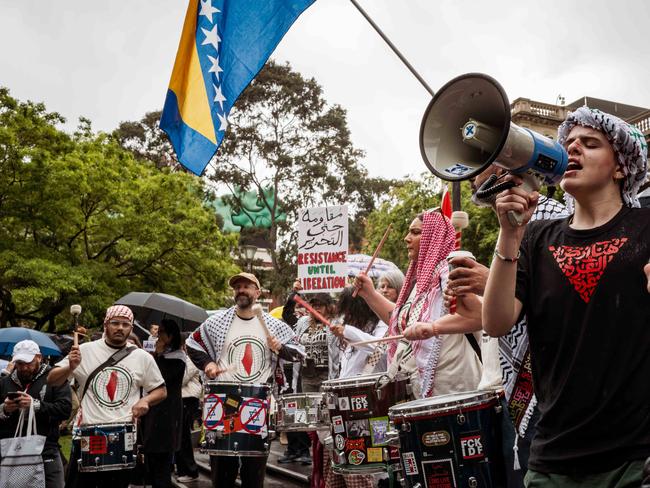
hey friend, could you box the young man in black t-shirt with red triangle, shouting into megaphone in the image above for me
[482,107,650,488]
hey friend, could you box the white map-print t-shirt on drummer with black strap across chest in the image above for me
[56,339,165,425]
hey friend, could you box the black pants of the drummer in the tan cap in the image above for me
[210,456,268,488]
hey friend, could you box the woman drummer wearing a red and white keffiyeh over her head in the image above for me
[356,209,481,398]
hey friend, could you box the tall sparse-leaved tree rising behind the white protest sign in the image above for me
[210,61,391,293]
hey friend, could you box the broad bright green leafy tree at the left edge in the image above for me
[0,89,236,331]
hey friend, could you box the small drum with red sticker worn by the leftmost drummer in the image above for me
[72,423,136,473]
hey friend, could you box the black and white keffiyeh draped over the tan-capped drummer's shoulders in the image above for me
[185,307,301,361]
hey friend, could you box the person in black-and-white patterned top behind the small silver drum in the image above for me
[278,293,338,486]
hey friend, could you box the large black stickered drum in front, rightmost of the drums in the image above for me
[388,391,505,487]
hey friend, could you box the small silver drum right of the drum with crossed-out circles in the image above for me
[276,393,330,432]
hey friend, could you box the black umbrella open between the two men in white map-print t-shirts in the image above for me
[115,291,208,330]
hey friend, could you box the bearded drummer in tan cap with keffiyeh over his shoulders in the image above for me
[186,273,303,488]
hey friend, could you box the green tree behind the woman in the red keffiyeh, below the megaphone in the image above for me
[366,174,499,270]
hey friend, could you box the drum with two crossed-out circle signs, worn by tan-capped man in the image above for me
[201,381,271,457]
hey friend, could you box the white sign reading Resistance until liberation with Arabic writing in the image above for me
[298,206,348,293]
